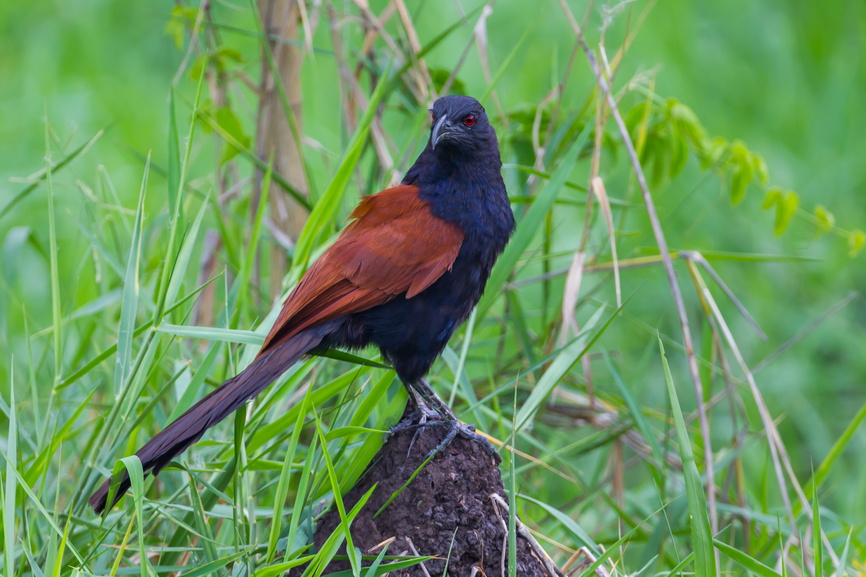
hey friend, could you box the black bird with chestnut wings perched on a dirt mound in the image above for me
[89,95,515,514]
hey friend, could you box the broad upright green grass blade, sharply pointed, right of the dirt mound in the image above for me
[659,337,716,577]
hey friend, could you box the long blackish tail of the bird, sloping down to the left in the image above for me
[90,327,327,513]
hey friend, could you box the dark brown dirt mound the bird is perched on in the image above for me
[315,418,551,577]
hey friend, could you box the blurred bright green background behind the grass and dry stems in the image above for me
[0,0,866,568]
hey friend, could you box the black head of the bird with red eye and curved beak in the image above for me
[430,95,496,154]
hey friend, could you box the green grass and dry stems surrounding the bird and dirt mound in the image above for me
[0,0,866,577]
